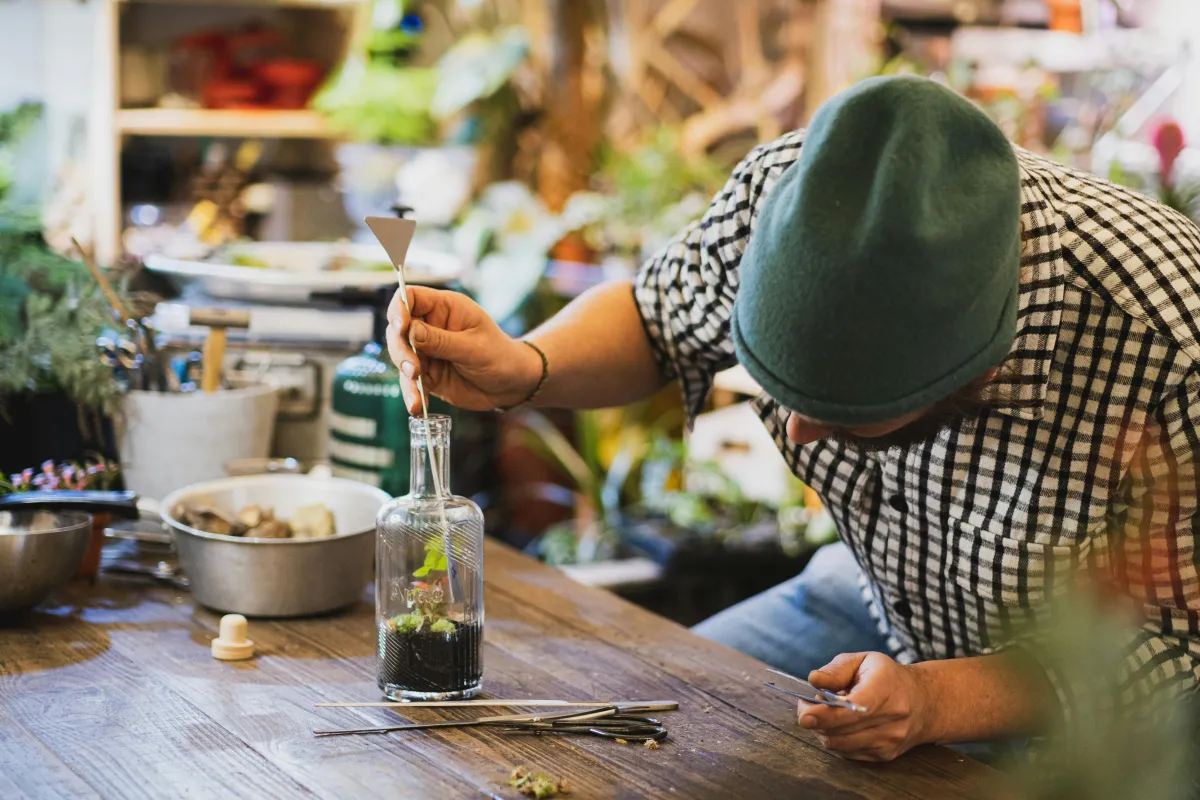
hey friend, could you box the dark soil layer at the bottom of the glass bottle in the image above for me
[379,621,484,697]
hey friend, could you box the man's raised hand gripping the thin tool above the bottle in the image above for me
[388,287,541,414]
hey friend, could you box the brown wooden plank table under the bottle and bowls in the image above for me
[0,543,995,800]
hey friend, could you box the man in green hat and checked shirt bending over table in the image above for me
[390,77,1200,760]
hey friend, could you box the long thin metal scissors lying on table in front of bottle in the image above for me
[313,705,667,741]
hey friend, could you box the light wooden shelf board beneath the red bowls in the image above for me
[116,108,337,139]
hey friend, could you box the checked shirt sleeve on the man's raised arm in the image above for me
[634,132,804,425]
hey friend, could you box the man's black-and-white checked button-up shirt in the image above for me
[634,132,1200,734]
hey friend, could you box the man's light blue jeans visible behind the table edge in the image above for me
[692,542,888,678]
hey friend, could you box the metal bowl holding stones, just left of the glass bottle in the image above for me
[160,475,390,616]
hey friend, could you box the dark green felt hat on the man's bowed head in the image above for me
[732,77,1021,425]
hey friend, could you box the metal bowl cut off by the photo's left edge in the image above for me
[0,511,91,613]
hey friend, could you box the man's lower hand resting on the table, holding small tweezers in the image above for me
[797,652,934,762]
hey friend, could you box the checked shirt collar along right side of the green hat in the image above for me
[995,150,1066,420]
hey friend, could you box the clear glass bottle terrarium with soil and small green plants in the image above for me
[376,414,484,700]
